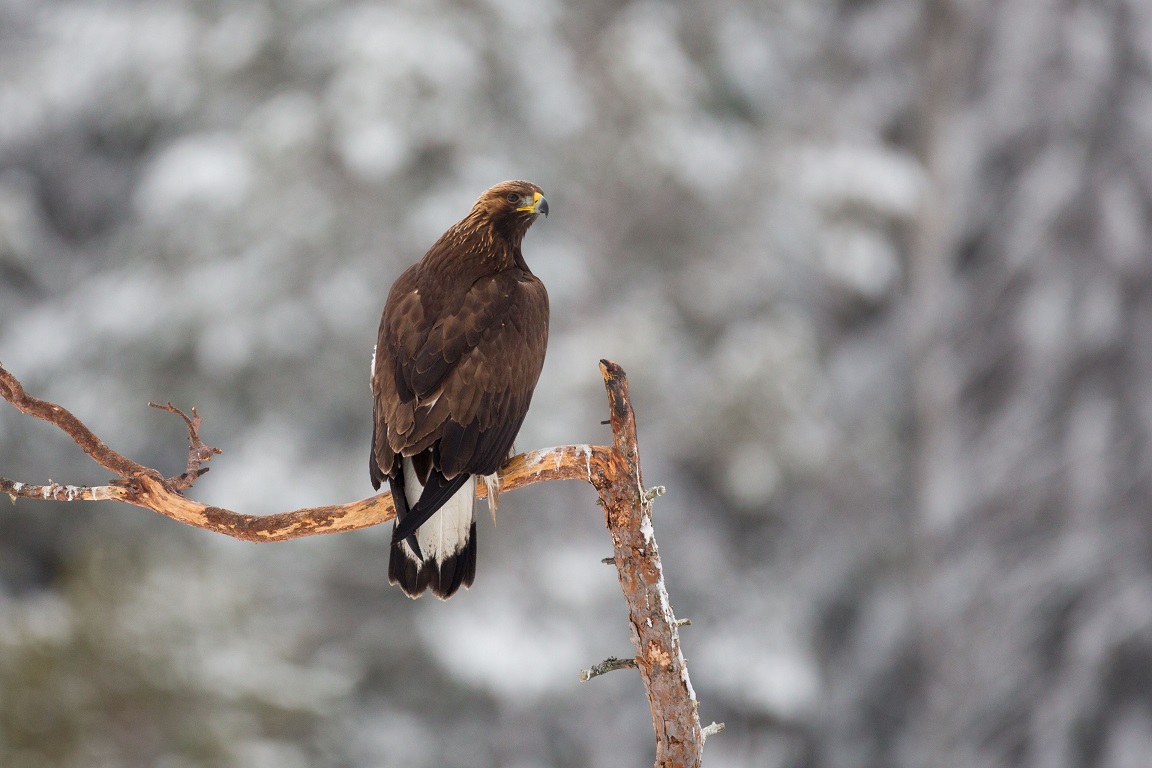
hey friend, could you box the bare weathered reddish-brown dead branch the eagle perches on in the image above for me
[0,360,722,768]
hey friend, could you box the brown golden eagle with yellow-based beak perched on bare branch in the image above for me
[369,181,548,600]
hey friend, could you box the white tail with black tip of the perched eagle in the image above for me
[388,458,476,600]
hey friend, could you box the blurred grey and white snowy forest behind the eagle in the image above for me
[0,0,1152,768]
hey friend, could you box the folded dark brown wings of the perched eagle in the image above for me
[373,269,548,478]
